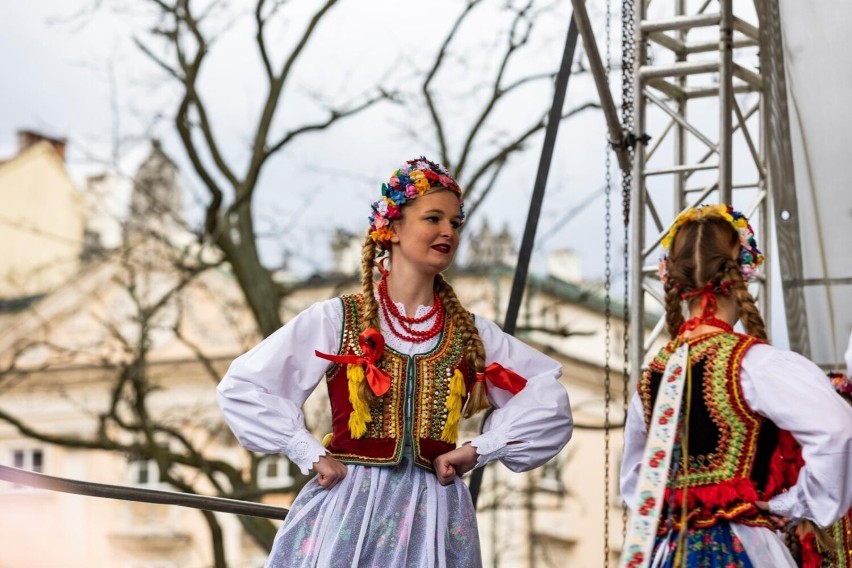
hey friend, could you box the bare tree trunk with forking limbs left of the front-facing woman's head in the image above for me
[131,0,386,336]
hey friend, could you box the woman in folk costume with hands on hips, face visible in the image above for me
[218,158,572,568]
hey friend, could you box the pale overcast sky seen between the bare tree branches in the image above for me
[0,0,632,279]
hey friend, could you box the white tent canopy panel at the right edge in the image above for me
[776,0,852,369]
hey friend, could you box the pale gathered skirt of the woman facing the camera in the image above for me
[266,457,482,568]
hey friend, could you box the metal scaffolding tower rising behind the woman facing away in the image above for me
[630,0,783,380]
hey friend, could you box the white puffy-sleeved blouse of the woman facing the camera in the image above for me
[217,298,573,473]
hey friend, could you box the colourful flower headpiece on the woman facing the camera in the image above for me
[370,156,464,249]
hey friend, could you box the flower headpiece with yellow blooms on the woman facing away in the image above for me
[658,204,764,282]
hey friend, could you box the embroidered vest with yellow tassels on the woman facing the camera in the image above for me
[326,294,474,471]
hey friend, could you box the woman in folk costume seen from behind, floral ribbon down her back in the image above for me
[621,205,852,568]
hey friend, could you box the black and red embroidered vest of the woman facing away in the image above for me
[638,333,778,533]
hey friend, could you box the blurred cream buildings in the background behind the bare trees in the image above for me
[0,132,660,568]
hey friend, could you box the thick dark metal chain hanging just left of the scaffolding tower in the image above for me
[621,0,641,540]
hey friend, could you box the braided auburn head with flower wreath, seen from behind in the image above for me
[661,206,766,340]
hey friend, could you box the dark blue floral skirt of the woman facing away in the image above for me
[653,523,759,568]
